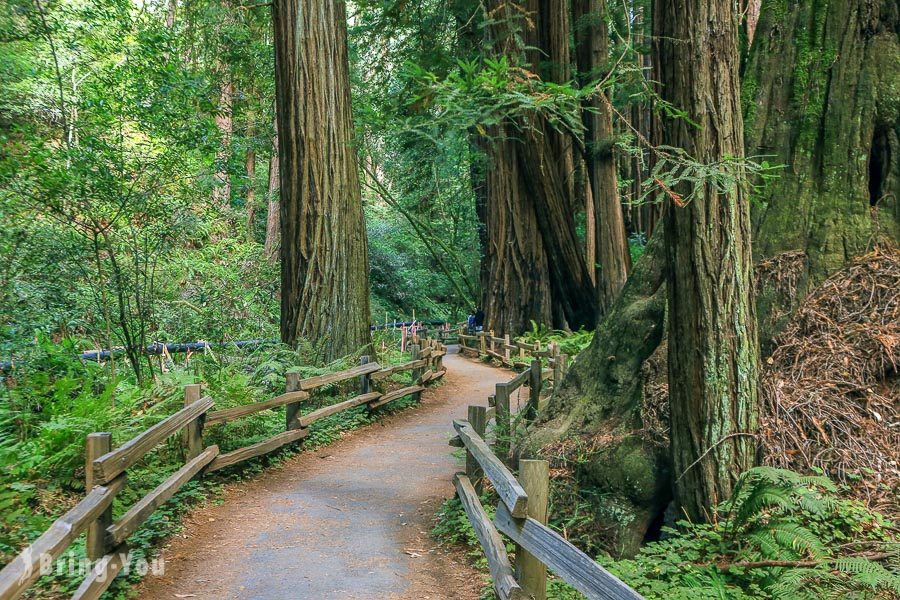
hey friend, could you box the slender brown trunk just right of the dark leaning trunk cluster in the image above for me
[572,0,631,311]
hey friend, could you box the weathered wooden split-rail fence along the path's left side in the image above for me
[0,338,447,600]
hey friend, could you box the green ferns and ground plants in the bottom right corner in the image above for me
[603,467,900,600]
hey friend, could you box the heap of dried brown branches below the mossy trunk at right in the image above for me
[762,250,900,516]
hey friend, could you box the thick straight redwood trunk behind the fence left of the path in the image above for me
[273,0,371,359]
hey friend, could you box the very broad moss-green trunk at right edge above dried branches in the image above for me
[743,0,900,344]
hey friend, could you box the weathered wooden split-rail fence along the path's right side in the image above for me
[450,333,641,600]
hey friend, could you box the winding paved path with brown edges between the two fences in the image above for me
[137,354,511,600]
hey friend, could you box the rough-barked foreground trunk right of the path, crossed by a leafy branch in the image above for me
[653,0,759,521]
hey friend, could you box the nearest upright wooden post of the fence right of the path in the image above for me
[516,460,550,600]
